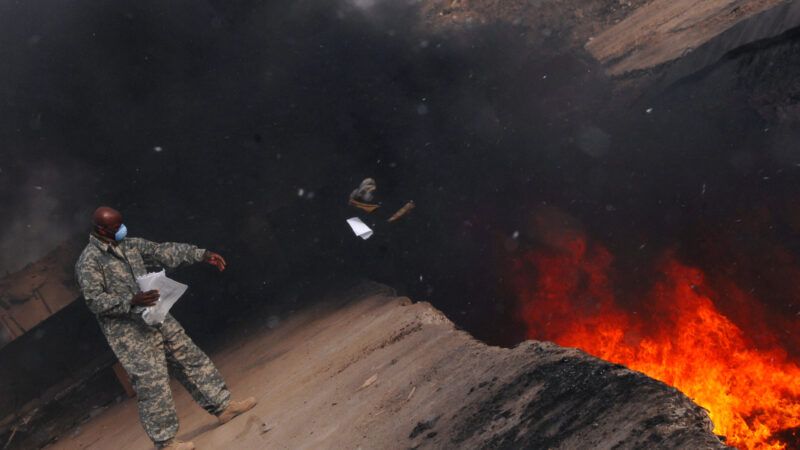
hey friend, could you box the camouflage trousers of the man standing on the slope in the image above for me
[106,315,230,444]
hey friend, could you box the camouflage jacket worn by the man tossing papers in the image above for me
[75,235,206,336]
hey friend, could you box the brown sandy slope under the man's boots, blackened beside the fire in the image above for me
[48,291,721,449]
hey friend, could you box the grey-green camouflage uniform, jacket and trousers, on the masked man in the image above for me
[75,235,230,444]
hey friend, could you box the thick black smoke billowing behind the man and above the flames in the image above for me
[0,1,800,352]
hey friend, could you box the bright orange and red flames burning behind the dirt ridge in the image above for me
[512,236,800,449]
